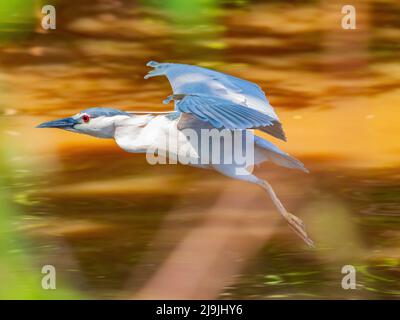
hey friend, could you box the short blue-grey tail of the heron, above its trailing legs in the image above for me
[254,136,309,173]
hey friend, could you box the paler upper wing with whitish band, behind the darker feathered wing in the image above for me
[145,61,279,121]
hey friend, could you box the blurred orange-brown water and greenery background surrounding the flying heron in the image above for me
[0,0,400,299]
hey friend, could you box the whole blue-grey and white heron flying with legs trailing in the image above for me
[38,61,313,246]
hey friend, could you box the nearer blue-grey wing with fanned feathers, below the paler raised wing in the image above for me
[176,94,286,140]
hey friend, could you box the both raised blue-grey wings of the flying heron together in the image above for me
[145,61,286,140]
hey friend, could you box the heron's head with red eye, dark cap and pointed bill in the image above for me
[37,108,131,138]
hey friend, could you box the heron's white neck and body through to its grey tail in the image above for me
[113,113,307,172]
